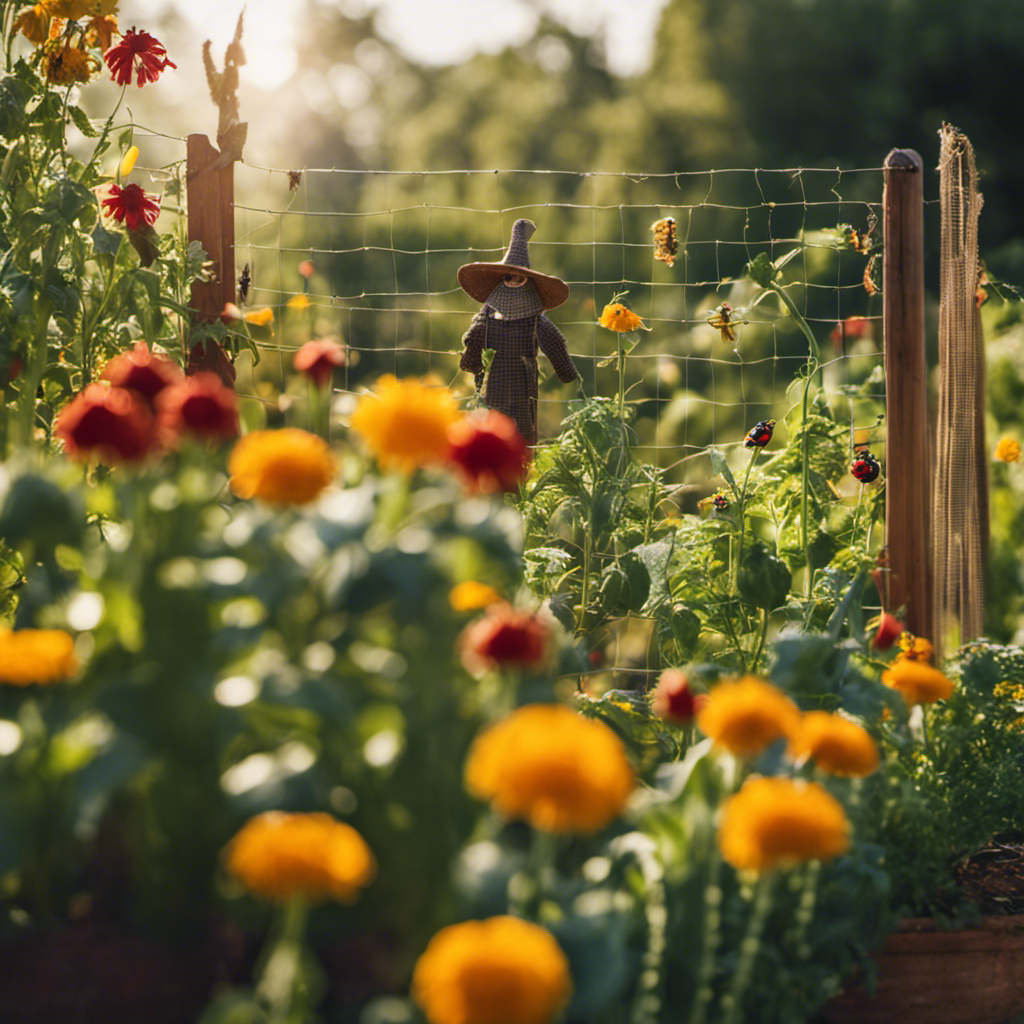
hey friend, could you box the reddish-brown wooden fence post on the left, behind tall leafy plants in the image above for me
[186,134,236,386]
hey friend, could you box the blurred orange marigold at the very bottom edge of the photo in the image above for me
[412,918,572,1024]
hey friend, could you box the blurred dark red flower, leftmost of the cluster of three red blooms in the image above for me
[54,384,156,464]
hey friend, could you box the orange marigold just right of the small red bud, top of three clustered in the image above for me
[697,676,800,757]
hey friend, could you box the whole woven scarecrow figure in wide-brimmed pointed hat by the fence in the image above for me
[459,220,578,444]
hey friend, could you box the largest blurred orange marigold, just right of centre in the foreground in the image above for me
[466,705,634,834]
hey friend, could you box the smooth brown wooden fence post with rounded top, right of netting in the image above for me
[882,150,934,638]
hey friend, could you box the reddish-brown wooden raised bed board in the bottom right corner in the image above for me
[822,916,1024,1024]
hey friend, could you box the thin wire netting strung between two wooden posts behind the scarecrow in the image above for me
[228,165,883,489]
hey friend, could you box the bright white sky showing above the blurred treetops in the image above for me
[134,0,668,89]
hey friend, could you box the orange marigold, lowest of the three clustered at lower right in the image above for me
[718,778,850,871]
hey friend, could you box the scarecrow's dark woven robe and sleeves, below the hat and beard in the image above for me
[459,306,577,444]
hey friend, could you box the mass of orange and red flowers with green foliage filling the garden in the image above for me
[0,8,1024,1024]
